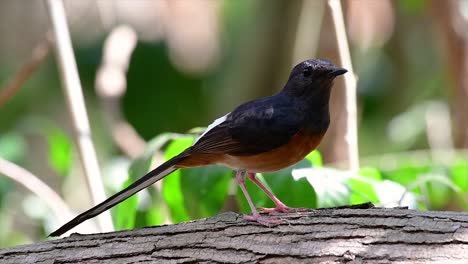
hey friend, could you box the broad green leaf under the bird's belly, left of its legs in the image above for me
[180,165,232,219]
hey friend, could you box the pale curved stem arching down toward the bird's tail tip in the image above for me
[0,158,73,223]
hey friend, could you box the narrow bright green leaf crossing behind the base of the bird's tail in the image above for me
[162,137,194,223]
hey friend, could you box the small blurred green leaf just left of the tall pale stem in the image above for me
[45,127,72,176]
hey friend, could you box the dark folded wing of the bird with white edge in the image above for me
[192,97,304,156]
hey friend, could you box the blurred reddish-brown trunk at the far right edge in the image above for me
[430,0,468,148]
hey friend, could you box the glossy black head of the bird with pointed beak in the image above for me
[283,59,347,100]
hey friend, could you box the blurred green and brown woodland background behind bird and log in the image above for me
[0,0,468,247]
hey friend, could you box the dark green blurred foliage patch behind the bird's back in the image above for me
[123,43,208,139]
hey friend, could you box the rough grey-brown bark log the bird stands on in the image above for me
[0,208,468,263]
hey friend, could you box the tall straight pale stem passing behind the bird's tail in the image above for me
[46,0,113,231]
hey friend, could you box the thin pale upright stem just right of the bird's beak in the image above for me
[328,0,359,171]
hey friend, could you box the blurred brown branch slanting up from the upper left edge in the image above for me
[0,32,52,108]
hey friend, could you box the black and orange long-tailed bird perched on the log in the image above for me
[49,59,347,237]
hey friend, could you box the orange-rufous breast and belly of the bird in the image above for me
[177,132,324,172]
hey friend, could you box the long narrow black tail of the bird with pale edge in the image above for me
[49,155,186,237]
